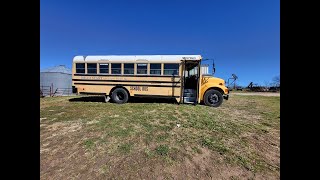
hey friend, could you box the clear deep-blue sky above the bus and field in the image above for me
[40,0,280,86]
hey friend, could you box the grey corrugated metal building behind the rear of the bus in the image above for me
[40,65,72,96]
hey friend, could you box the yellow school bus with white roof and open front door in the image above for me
[72,55,229,107]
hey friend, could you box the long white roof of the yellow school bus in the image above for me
[73,55,202,62]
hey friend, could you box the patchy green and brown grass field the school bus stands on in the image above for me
[40,95,280,179]
